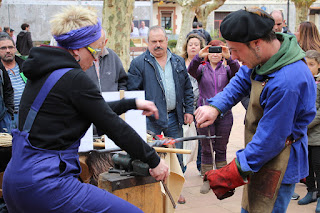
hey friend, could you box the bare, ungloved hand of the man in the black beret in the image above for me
[194,106,219,128]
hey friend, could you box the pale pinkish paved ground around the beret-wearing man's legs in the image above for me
[176,104,316,213]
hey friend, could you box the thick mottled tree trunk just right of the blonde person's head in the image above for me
[102,0,135,71]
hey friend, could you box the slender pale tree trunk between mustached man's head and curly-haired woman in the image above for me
[176,6,195,55]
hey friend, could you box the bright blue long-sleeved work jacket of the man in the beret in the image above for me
[208,60,316,184]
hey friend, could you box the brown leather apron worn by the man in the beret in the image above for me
[241,73,291,213]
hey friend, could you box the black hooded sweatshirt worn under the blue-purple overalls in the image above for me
[19,46,160,168]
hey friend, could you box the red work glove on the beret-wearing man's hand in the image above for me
[204,159,248,200]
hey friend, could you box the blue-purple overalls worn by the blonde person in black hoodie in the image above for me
[3,69,142,213]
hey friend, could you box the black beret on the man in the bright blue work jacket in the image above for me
[220,9,274,43]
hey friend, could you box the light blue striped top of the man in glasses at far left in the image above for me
[7,64,25,112]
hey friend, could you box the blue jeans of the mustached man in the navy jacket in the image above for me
[147,111,185,172]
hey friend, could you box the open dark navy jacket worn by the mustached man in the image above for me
[128,50,193,128]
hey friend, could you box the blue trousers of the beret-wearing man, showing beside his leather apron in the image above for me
[241,184,295,213]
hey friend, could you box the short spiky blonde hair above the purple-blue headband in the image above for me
[50,6,98,35]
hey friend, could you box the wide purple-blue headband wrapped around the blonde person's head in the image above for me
[53,20,101,50]
